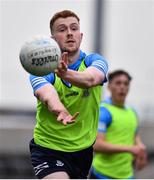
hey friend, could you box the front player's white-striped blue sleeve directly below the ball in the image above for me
[29,73,55,92]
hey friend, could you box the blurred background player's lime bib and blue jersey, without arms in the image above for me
[93,99,137,179]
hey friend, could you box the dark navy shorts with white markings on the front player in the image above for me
[30,139,93,179]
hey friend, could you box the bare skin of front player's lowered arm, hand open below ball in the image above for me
[35,84,78,125]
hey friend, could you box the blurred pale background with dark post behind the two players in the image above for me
[0,0,154,179]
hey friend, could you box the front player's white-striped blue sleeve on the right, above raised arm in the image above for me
[85,54,108,76]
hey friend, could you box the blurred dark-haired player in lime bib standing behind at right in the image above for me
[91,70,146,179]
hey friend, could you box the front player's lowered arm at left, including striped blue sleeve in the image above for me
[30,76,78,125]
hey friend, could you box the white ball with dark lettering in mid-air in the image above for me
[19,36,61,76]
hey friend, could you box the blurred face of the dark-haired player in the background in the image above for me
[109,75,130,102]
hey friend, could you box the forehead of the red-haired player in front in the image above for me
[53,16,79,28]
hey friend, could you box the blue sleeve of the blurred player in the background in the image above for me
[98,106,112,133]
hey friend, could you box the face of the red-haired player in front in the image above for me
[53,17,83,53]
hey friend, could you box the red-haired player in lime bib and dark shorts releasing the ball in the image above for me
[30,10,108,179]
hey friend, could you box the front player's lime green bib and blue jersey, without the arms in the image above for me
[30,51,108,152]
